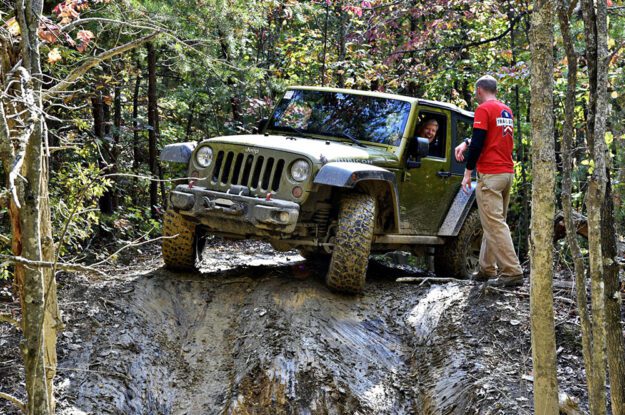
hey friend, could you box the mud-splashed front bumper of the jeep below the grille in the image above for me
[169,185,299,235]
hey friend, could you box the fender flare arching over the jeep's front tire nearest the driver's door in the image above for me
[314,162,399,231]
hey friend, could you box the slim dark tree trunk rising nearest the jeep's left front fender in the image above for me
[148,42,159,218]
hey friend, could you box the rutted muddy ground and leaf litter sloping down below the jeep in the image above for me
[0,239,616,414]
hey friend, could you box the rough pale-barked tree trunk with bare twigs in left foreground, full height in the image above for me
[12,0,59,414]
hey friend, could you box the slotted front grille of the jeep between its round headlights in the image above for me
[209,150,285,192]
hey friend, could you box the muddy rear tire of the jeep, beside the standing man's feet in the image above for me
[434,209,482,278]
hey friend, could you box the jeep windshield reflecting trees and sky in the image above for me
[268,89,410,146]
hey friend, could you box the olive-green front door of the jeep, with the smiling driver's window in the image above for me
[399,106,462,235]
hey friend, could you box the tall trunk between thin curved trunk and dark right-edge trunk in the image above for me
[582,0,607,415]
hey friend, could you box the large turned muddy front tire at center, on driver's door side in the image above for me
[326,194,376,293]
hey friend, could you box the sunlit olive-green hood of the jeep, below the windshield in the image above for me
[203,134,398,166]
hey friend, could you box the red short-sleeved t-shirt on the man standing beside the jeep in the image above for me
[473,100,514,174]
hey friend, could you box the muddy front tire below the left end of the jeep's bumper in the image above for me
[162,210,197,271]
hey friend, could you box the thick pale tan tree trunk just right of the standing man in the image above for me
[530,0,559,415]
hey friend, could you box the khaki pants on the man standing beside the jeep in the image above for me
[475,173,523,277]
